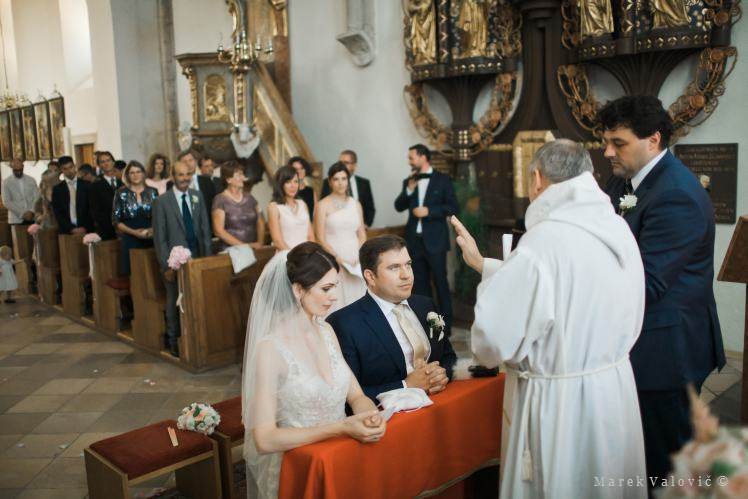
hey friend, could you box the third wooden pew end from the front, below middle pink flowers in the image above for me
[91,239,121,334]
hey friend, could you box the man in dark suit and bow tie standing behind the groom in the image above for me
[395,144,459,326]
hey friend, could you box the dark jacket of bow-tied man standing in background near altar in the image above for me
[395,170,460,253]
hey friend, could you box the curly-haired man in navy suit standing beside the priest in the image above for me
[598,96,725,490]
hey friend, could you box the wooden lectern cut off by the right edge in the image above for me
[717,215,748,425]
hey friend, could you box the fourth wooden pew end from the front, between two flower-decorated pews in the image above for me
[58,234,89,317]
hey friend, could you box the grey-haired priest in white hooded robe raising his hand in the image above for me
[452,140,647,499]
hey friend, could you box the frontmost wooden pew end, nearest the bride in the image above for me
[178,247,275,371]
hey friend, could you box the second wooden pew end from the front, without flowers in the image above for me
[130,248,166,353]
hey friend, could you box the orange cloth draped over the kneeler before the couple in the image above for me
[278,374,504,499]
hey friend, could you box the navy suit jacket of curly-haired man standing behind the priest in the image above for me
[605,152,725,390]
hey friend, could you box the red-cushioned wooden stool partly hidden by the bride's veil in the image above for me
[211,397,244,499]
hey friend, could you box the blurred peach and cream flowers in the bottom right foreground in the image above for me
[660,387,748,499]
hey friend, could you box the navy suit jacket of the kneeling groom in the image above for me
[327,293,457,401]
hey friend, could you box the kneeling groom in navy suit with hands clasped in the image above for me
[327,235,457,400]
